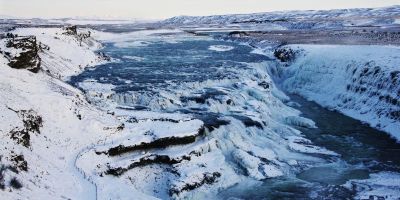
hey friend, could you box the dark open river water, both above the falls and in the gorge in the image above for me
[71,30,400,199]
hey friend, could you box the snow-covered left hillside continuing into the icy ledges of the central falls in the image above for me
[1,28,354,199]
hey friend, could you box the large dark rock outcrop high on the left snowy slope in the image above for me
[3,35,41,73]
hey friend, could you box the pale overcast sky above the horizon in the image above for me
[0,0,400,19]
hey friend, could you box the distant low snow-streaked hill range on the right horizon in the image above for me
[161,6,400,30]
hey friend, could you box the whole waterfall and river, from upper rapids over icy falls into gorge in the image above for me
[71,30,400,199]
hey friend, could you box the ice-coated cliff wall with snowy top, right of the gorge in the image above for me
[281,45,400,140]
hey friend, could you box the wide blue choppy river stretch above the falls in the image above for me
[71,36,269,93]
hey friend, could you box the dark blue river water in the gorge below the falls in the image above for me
[220,95,400,200]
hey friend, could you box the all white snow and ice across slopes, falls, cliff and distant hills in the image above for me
[0,6,400,199]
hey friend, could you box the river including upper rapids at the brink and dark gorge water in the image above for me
[70,30,400,199]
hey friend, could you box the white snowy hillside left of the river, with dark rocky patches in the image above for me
[0,28,119,199]
